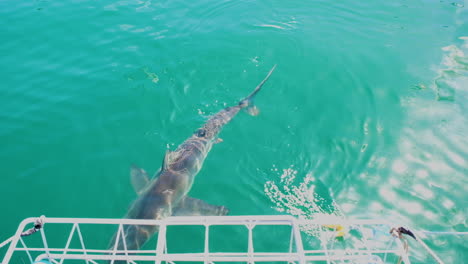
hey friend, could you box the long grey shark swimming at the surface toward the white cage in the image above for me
[110,65,276,255]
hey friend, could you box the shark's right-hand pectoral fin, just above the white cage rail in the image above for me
[172,197,229,216]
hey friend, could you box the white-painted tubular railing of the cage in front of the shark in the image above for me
[0,216,410,264]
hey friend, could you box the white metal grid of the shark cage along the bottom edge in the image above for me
[2,216,410,264]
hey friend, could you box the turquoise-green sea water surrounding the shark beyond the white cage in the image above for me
[0,0,468,263]
